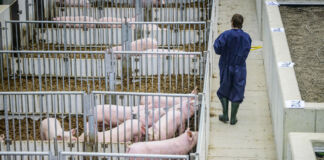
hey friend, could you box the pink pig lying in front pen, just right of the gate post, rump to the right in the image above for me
[79,119,145,143]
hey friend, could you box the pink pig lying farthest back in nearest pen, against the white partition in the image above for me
[140,87,198,108]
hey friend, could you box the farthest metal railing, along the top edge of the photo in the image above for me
[27,0,211,21]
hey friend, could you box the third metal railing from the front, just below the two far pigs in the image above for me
[0,20,207,51]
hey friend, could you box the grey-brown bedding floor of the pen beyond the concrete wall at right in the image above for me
[279,6,324,103]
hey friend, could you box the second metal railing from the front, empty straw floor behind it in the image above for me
[0,50,204,93]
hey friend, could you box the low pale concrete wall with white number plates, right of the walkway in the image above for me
[257,0,324,160]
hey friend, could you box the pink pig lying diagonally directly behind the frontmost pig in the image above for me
[148,109,186,141]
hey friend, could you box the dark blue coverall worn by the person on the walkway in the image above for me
[214,29,252,103]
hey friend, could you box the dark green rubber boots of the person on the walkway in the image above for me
[219,98,240,125]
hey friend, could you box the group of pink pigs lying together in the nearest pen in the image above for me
[40,89,198,154]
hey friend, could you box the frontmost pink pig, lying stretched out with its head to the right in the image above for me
[127,129,198,160]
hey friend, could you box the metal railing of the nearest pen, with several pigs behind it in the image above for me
[0,91,200,156]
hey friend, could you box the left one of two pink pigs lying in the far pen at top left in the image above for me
[53,16,97,28]
